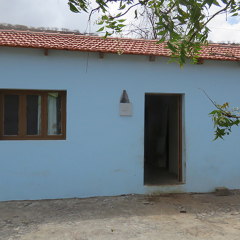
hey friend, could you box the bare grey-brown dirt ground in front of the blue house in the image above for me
[0,190,240,240]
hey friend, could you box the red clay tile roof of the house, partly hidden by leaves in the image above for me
[0,30,240,61]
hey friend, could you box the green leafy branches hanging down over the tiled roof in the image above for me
[68,0,240,67]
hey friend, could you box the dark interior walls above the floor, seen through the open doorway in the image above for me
[145,94,178,174]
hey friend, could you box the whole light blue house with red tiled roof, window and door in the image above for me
[0,30,240,201]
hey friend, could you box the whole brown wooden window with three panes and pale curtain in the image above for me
[0,90,66,140]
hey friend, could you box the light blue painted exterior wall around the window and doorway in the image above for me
[0,47,240,201]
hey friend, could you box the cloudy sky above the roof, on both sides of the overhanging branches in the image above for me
[0,0,240,43]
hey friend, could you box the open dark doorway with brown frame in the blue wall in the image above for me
[144,93,182,185]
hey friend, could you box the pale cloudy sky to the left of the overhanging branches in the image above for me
[0,0,100,32]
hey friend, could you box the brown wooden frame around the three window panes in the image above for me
[0,89,67,140]
